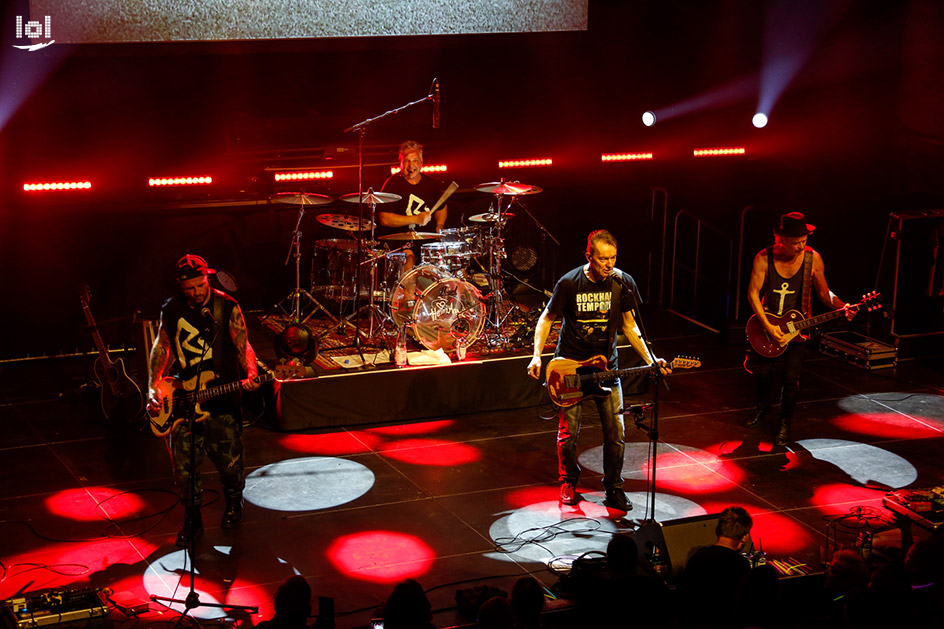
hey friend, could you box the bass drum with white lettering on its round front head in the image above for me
[391,265,486,352]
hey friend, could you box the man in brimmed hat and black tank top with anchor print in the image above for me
[746,212,856,446]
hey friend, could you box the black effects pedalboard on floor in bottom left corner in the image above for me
[2,588,108,629]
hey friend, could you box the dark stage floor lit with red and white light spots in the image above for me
[0,312,944,628]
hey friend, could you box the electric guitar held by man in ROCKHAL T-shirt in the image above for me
[547,354,701,407]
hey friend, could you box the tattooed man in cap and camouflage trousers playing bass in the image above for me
[148,255,259,548]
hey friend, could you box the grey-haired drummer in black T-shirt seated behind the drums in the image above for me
[377,140,447,272]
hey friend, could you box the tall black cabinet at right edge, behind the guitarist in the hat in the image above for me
[885,210,944,338]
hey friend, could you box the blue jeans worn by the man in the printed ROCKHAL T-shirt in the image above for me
[557,381,625,489]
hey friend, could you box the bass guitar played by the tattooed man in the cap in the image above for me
[148,365,305,437]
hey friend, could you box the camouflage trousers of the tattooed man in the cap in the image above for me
[171,414,246,506]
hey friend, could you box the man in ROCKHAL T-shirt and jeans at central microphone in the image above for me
[528,229,670,511]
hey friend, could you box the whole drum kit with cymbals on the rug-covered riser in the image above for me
[270,180,542,356]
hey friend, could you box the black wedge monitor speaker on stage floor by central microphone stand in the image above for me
[633,513,719,580]
